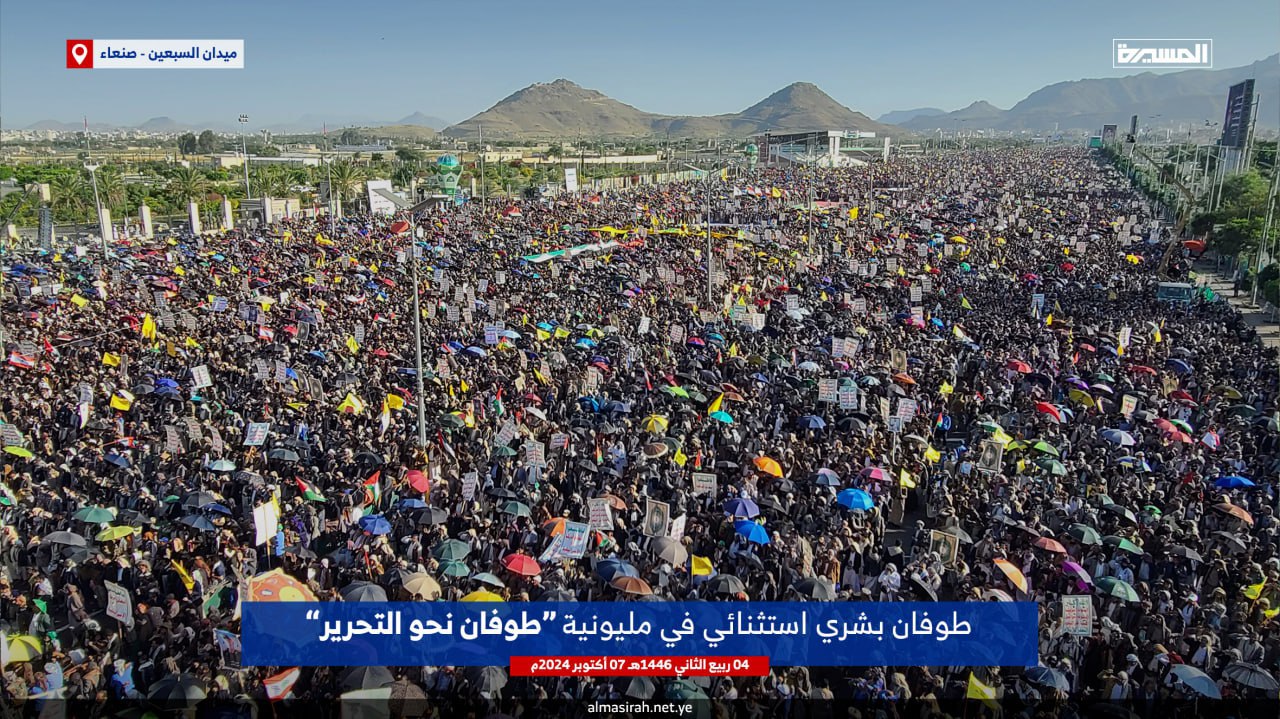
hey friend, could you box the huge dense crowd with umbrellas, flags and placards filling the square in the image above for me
[0,147,1280,718]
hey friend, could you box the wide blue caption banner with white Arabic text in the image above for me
[241,601,1039,667]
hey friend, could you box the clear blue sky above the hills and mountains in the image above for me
[0,0,1280,128]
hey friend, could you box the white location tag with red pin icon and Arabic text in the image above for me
[67,38,244,70]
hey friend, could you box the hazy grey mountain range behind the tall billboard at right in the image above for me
[902,54,1280,132]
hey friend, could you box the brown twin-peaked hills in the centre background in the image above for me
[444,79,902,138]
